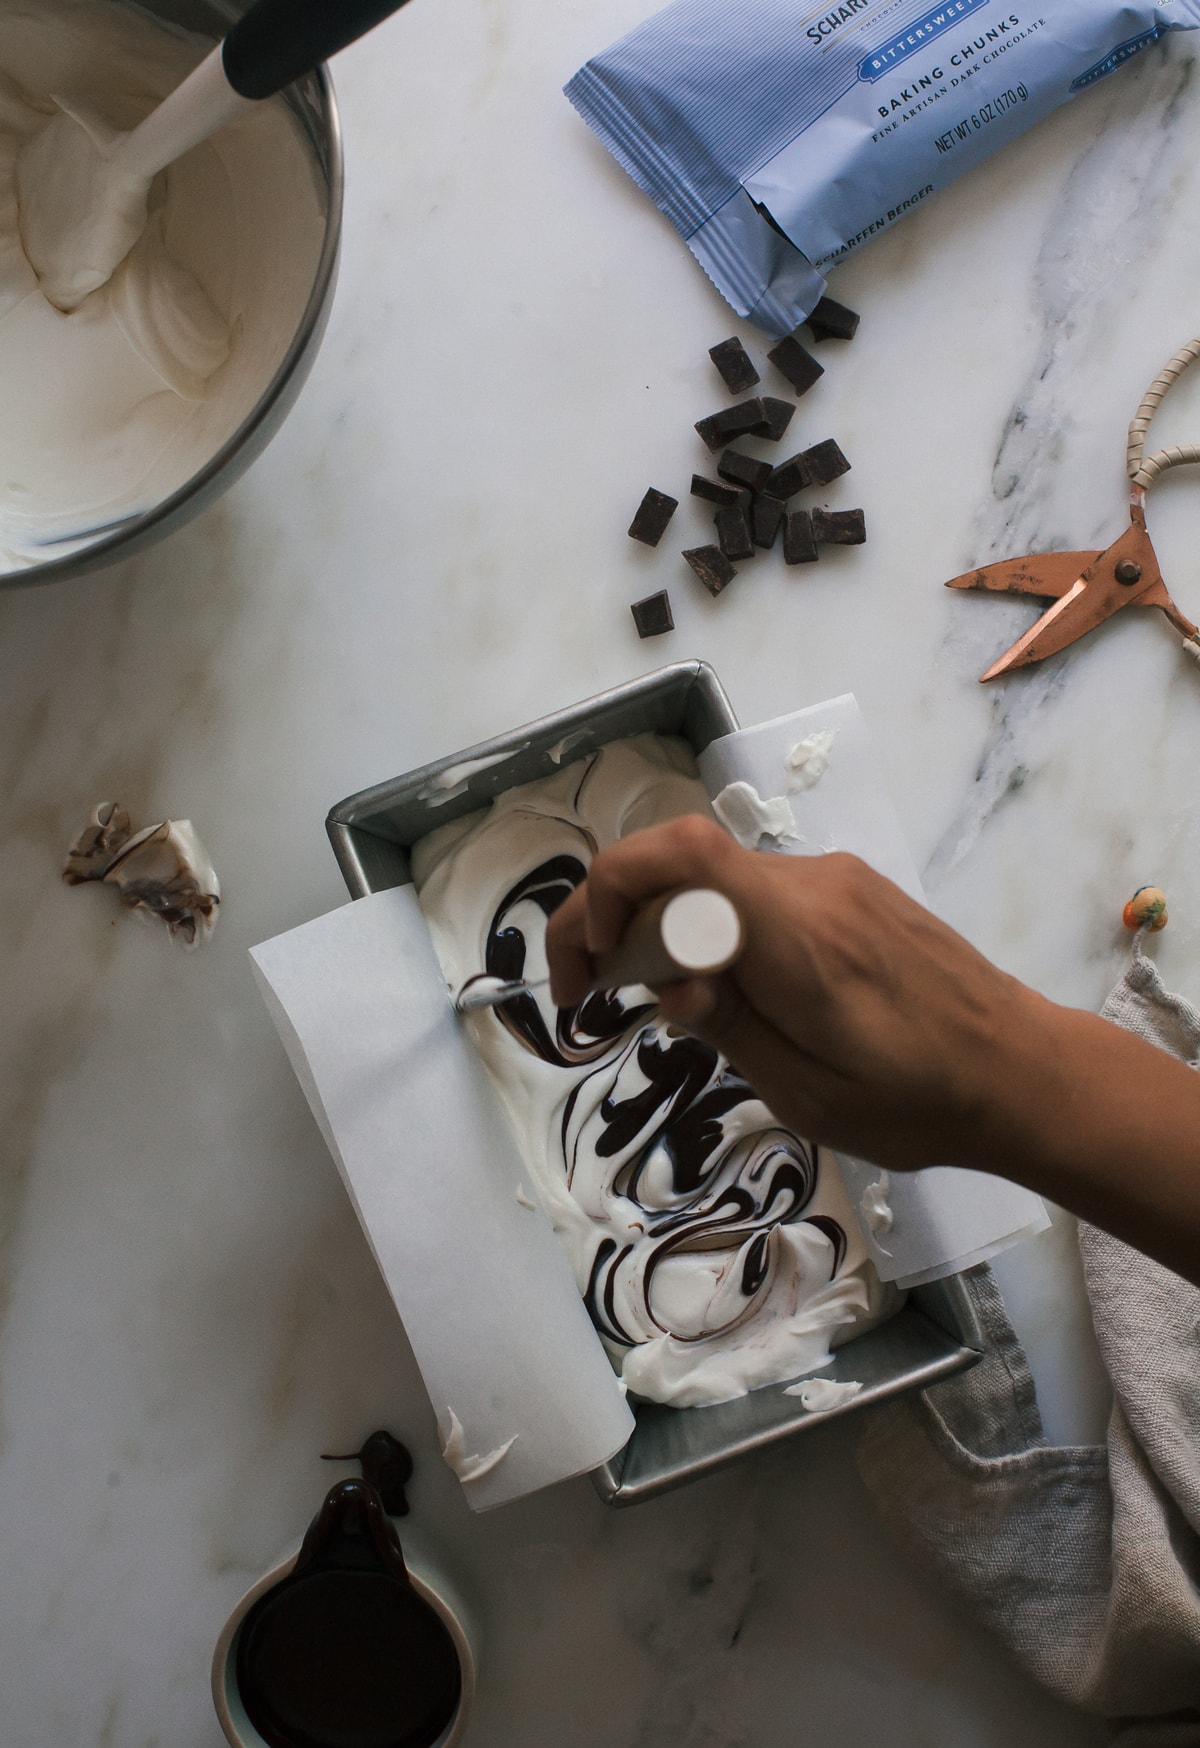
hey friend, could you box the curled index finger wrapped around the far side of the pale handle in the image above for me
[584,813,745,953]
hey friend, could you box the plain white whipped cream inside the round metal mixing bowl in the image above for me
[0,0,324,572]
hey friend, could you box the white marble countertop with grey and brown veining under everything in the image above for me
[0,0,1200,1748]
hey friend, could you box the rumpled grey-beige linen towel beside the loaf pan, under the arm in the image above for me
[859,947,1200,1748]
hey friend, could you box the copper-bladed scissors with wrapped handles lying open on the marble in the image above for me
[946,339,1200,680]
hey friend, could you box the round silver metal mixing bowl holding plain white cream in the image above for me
[0,0,343,589]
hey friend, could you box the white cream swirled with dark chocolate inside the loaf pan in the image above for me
[413,734,899,1407]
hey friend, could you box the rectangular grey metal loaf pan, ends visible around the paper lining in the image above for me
[325,661,980,1505]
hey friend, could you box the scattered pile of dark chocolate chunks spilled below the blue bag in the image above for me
[630,297,866,638]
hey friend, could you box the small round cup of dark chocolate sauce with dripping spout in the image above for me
[212,1481,476,1748]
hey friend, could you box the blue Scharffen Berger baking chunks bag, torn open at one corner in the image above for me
[567,0,1200,336]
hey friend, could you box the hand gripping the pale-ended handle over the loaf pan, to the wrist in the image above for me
[546,815,1053,1169]
